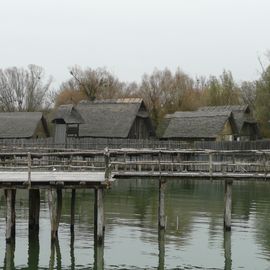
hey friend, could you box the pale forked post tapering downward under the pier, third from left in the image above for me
[48,189,62,242]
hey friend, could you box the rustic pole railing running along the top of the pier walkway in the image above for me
[0,148,270,179]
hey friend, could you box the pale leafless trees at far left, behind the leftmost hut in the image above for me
[0,65,52,111]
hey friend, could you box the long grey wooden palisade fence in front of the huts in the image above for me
[0,137,270,151]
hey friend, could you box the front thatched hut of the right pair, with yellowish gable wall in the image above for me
[157,111,237,142]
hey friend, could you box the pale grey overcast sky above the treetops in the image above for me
[0,0,270,85]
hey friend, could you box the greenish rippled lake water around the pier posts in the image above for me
[0,180,270,270]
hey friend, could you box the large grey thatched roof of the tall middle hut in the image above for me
[76,98,149,138]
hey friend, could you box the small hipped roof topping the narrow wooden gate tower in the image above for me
[52,104,84,124]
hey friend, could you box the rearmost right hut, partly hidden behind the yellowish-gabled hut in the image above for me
[198,105,260,141]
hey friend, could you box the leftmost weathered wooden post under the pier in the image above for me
[5,189,16,242]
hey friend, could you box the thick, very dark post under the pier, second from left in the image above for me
[29,189,40,231]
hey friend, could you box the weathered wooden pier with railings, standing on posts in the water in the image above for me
[0,148,270,243]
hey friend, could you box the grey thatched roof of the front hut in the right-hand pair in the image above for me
[160,111,233,139]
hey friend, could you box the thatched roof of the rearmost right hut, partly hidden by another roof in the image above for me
[198,105,253,133]
